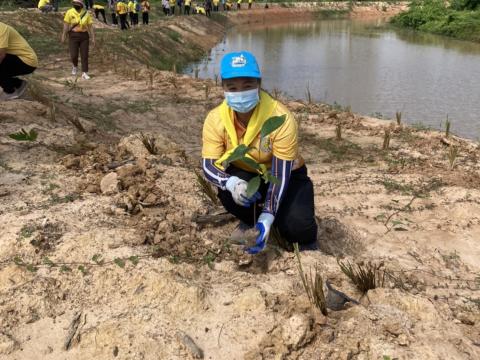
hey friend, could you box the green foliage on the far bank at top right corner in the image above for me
[391,0,480,41]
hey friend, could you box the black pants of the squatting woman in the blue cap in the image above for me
[218,166,317,244]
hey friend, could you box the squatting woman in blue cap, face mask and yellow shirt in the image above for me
[202,51,317,254]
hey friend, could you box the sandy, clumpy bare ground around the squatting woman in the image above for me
[0,4,480,360]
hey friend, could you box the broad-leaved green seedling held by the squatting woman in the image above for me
[225,115,287,197]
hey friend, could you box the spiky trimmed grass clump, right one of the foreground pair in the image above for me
[337,259,385,294]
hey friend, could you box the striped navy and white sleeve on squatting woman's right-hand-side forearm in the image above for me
[263,156,293,215]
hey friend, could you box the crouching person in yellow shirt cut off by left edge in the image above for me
[0,22,38,100]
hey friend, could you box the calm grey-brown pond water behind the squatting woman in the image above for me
[186,20,480,139]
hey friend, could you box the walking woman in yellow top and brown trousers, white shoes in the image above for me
[62,0,95,80]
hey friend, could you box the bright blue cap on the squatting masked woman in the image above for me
[220,51,261,79]
